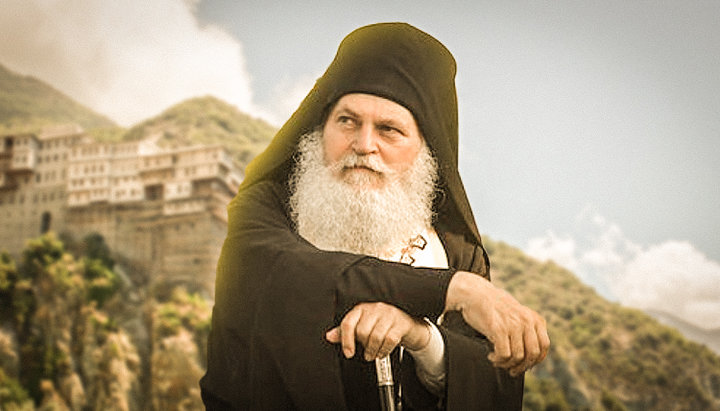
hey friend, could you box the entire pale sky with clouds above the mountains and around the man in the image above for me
[0,0,720,328]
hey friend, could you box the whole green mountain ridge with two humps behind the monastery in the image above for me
[0,64,277,166]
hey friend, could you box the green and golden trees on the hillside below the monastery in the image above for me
[0,233,211,410]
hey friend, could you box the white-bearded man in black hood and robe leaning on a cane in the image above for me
[201,23,549,410]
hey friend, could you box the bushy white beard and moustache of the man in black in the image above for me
[290,131,437,258]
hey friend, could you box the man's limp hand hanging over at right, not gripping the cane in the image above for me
[445,271,550,376]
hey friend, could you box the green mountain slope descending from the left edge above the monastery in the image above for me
[0,65,115,133]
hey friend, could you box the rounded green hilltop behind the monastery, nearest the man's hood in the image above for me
[123,96,276,164]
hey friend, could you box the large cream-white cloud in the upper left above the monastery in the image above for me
[0,0,263,125]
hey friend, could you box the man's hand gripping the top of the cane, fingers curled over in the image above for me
[325,303,430,361]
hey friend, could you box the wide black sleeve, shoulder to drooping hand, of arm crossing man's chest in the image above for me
[201,182,453,409]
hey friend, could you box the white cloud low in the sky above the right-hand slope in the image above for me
[526,210,720,328]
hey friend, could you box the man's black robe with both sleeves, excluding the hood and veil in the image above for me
[200,180,523,410]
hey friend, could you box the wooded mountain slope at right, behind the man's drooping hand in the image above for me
[487,241,720,410]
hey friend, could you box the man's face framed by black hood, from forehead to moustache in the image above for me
[323,93,423,188]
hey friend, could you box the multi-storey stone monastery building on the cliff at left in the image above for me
[0,128,241,298]
